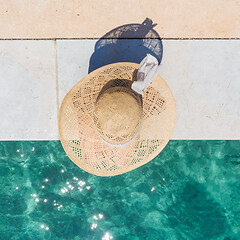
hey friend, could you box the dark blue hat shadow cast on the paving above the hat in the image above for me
[88,18,163,73]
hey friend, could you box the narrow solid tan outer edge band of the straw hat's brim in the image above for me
[58,62,176,177]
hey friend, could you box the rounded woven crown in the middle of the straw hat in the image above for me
[93,87,143,146]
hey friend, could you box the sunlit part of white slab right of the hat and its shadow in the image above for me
[160,40,240,139]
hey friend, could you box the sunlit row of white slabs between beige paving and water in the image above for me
[0,39,240,140]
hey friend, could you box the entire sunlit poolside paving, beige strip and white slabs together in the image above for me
[0,0,240,140]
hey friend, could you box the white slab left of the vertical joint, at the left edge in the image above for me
[0,40,58,140]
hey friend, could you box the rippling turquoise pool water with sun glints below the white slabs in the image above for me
[0,141,240,240]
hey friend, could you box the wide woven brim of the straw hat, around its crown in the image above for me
[58,62,176,176]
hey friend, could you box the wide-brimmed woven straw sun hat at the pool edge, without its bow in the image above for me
[58,62,176,176]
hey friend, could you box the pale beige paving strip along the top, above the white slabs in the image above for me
[0,0,240,39]
